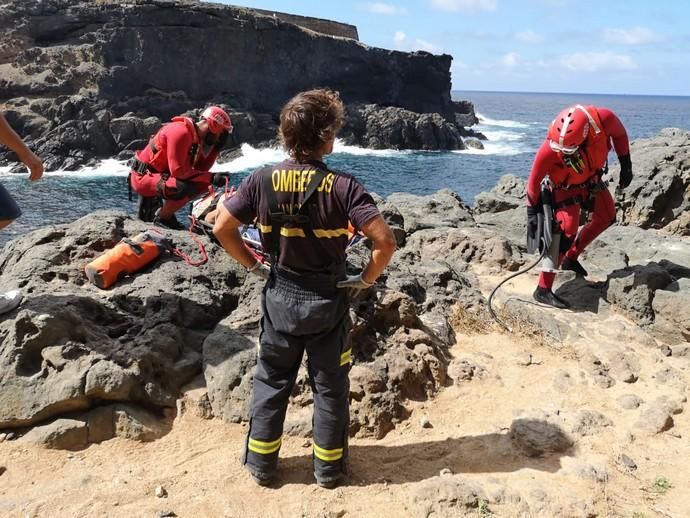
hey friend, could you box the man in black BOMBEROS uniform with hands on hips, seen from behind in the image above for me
[213,90,395,488]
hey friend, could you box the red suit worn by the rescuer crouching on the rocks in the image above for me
[130,117,219,217]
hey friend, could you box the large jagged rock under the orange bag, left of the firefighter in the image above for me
[0,212,245,434]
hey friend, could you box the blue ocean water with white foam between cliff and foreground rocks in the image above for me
[0,92,690,245]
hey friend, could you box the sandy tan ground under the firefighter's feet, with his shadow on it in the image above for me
[0,270,690,518]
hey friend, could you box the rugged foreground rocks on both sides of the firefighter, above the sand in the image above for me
[0,129,690,438]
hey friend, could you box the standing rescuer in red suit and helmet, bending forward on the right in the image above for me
[527,104,633,309]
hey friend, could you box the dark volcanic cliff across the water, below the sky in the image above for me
[0,0,474,168]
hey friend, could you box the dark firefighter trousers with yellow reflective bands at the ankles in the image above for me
[244,271,352,484]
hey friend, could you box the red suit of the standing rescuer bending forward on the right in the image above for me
[527,106,629,289]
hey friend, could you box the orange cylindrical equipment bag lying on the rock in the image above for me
[84,232,172,289]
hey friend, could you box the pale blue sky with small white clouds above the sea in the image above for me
[216,0,690,95]
